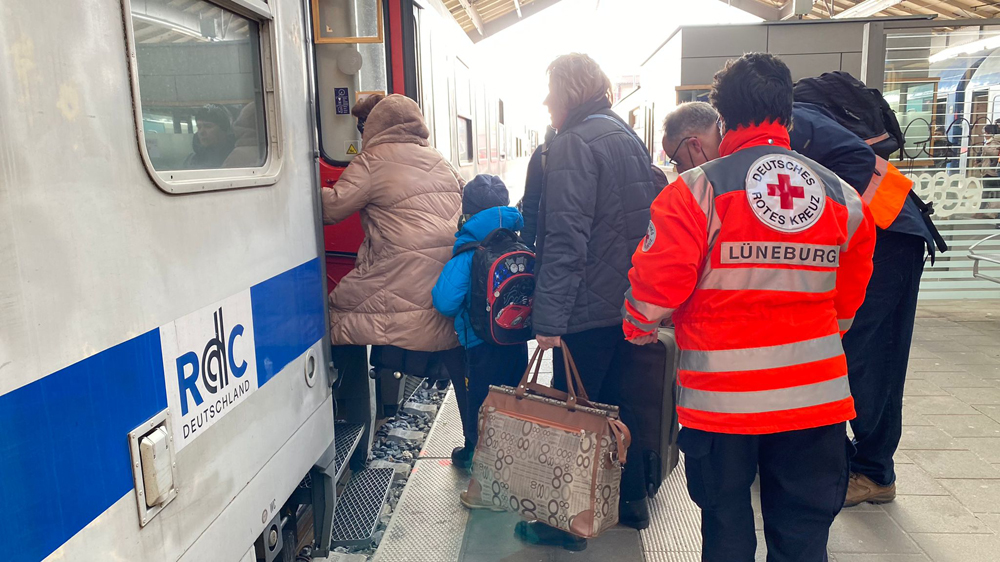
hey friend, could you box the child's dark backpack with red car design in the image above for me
[455,228,535,345]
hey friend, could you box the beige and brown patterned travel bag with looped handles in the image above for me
[468,344,631,538]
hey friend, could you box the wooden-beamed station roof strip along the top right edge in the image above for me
[720,0,1000,21]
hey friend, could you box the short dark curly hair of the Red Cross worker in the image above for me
[708,53,793,130]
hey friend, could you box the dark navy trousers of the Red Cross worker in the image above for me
[678,423,851,562]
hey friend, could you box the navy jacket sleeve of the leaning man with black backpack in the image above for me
[789,103,875,193]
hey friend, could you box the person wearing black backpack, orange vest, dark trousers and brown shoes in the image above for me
[792,72,948,507]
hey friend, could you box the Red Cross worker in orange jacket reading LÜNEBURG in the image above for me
[623,53,875,562]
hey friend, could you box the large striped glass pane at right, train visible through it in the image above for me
[883,26,1000,298]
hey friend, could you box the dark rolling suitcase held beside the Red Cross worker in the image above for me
[622,328,680,496]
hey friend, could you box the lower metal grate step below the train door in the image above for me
[331,468,393,547]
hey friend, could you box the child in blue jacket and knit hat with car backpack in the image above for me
[431,174,535,482]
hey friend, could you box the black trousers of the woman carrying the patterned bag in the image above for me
[552,326,646,501]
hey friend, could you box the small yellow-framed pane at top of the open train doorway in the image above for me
[312,0,382,44]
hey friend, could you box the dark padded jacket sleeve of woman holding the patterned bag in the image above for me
[532,134,598,336]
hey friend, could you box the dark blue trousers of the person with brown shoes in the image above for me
[844,230,925,486]
